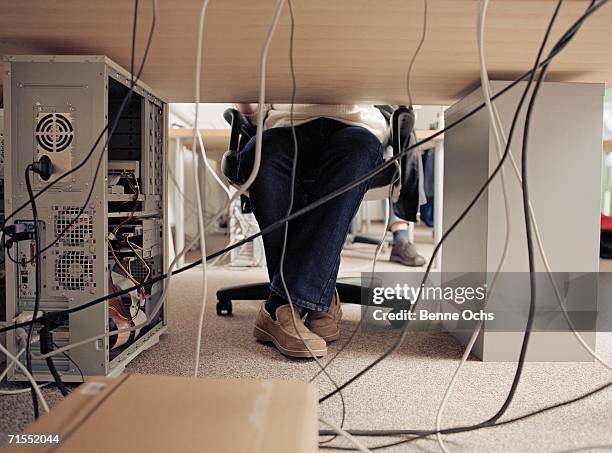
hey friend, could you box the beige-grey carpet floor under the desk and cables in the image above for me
[0,237,612,453]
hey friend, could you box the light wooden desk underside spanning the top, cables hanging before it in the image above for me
[0,0,612,105]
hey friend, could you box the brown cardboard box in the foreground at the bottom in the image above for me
[13,374,318,453]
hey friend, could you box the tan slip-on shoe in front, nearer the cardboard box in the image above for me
[253,302,327,357]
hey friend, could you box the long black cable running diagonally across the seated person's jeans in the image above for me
[0,0,608,342]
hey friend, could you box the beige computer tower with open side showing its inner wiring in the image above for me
[4,56,168,382]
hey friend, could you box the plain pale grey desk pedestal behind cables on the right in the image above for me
[436,82,607,362]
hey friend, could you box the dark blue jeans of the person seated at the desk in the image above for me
[238,118,382,311]
